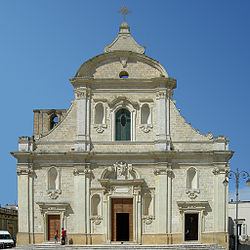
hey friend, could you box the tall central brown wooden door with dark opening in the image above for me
[111,198,133,241]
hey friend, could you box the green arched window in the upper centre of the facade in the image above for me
[115,109,131,141]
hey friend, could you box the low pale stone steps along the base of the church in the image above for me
[16,243,225,250]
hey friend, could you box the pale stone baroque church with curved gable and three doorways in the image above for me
[11,15,233,247]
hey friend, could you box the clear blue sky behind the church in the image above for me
[0,0,250,205]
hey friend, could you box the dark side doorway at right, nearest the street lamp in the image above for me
[185,214,198,241]
